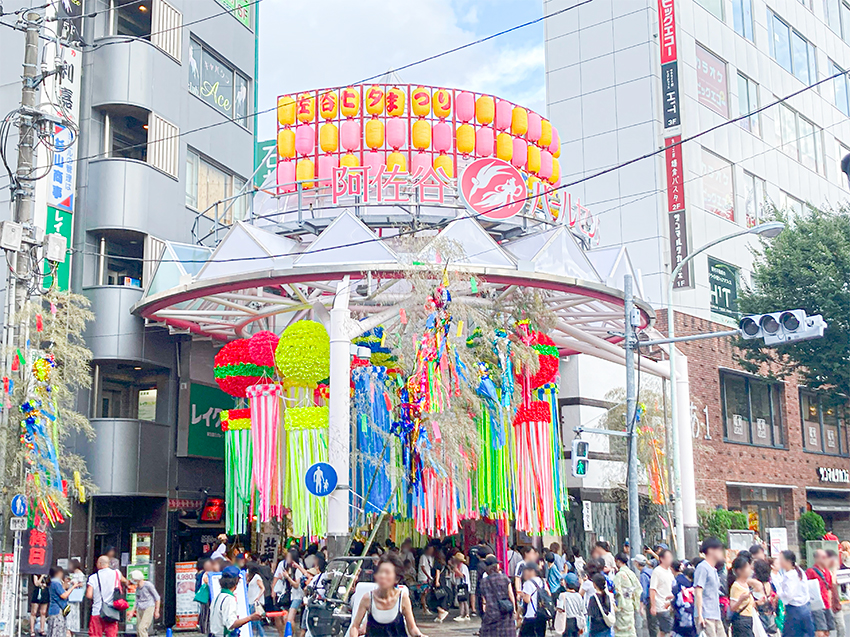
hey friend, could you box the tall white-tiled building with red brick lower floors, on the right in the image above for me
[544,0,850,544]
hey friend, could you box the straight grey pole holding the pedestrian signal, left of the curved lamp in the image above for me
[623,274,643,568]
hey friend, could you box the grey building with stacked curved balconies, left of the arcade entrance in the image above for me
[0,0,256,624]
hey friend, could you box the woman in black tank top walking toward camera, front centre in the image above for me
[348,553,425,637]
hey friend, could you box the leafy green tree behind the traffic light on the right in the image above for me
[736,207,850,395]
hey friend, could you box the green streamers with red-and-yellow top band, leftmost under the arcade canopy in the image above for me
[219,409,254,535]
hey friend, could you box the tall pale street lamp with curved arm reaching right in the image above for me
[667,221,785,558]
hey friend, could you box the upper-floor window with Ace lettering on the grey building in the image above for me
[189,39,249,128]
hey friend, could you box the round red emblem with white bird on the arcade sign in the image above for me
[460,157,527,219]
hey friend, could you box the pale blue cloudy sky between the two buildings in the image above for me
[258,0,546,140]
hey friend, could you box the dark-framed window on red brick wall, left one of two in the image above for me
[720,372,785,447]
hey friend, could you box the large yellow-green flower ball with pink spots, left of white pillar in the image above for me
[274,320,331,387]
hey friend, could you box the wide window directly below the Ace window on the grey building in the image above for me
[186,148,249,223]
